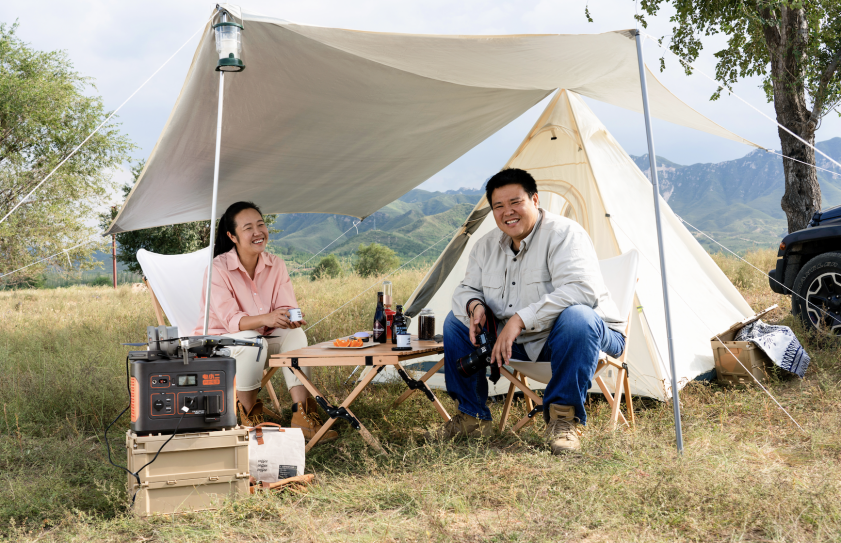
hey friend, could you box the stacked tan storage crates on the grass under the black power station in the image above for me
[126,428,248,517]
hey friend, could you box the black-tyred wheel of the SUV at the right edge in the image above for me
[791,253,841,334]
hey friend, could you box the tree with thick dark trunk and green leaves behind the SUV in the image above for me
[637,0,841,232]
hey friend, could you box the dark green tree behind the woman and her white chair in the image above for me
[100,160,279,273]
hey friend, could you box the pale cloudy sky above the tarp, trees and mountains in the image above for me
[0,0,841,196]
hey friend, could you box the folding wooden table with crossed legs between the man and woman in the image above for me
[264,336,450,453]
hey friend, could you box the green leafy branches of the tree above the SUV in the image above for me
[636,0,841,116]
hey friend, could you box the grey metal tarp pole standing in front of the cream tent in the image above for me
[636,30,683,454]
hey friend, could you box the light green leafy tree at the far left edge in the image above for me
[0,24,133,286]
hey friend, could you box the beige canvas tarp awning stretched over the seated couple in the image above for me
[108,4,755,233]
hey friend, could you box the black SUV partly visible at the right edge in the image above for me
[768,206,841,334]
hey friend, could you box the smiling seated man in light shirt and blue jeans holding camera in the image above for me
[434,169,625,454]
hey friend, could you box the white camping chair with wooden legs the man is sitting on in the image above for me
[499,249,639,432]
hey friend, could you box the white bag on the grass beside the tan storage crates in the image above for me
[248,422,305,484]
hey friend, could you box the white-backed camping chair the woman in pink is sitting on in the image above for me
[137,247,282,419]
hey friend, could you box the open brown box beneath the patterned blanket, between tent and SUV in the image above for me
[710,305,777,385]
